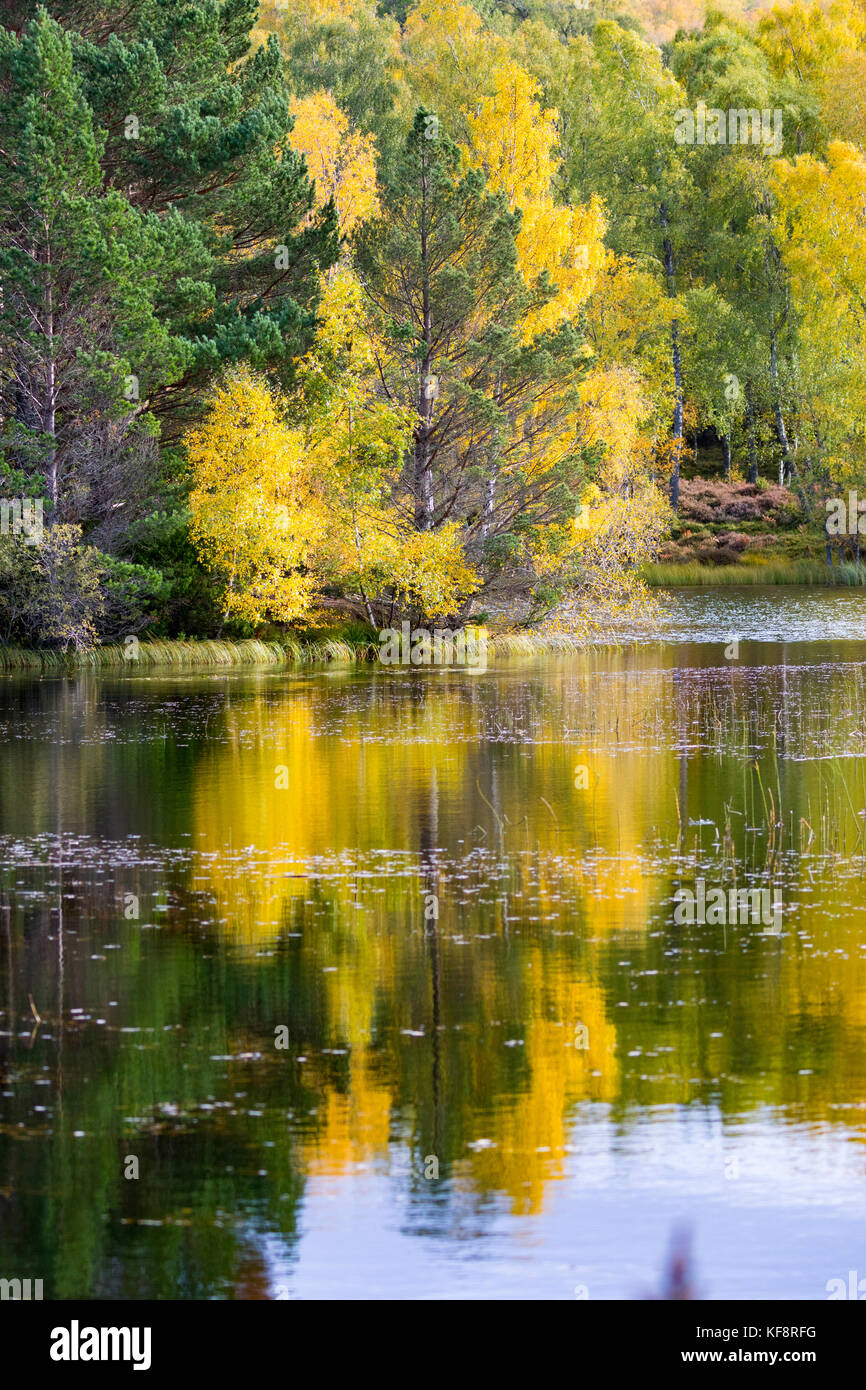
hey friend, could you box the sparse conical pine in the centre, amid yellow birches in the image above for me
[354,108,585,546]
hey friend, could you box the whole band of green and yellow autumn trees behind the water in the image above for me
[0,0,866,646]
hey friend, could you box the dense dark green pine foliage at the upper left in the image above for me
[0,0,336,500]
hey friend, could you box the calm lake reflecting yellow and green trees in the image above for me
[0,588,866,1300]
